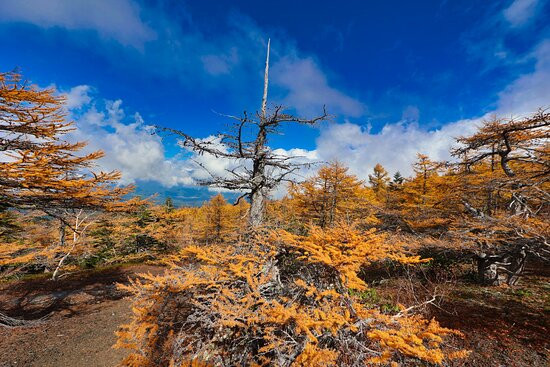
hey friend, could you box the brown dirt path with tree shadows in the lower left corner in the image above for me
[0,265,162,367]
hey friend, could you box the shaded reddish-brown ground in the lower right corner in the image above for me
[377,263,550,367]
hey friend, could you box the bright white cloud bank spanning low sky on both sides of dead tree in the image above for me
[66,35,550,196]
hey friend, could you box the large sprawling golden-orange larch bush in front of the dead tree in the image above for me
[117,224,466,367]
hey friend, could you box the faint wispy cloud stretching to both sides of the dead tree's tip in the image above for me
[142,13,367,117]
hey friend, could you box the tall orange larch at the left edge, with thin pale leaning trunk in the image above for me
[0,72,131,284]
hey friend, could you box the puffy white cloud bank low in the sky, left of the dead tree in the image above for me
[65,85,317,195]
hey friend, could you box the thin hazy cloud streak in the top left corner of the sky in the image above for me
[0,0,155,48]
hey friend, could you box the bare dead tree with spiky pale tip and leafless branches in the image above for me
[158,41,328,227]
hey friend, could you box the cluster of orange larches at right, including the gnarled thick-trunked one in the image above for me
[374,110,550,284]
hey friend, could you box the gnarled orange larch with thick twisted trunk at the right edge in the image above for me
[452,110,550,285]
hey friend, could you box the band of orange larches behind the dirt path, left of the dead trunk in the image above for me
[0,195,249,275]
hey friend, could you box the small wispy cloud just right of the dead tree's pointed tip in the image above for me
[270,56,365,117]
